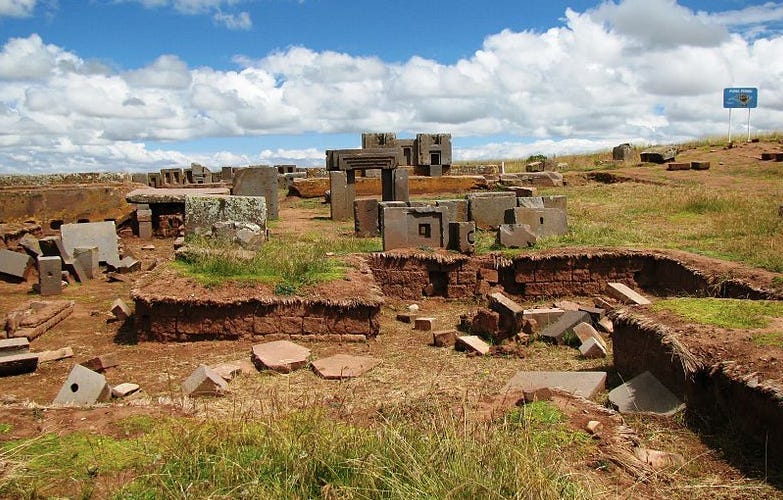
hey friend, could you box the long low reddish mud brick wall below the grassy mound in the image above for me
[135,298,380,342]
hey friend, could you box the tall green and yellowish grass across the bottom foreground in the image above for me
[0,403,595,499]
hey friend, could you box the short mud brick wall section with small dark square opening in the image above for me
[369,255,479,300]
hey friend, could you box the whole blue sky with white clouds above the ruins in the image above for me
[0,0,783,173]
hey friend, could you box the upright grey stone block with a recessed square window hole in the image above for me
[381,207,449,251]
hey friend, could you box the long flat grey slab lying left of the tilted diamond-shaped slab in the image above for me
[503,372,606,399]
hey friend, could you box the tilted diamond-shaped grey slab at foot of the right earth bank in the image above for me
[609,372,683,415]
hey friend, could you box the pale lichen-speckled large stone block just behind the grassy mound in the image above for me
[185,195,267,234]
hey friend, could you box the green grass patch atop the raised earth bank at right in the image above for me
[651,297,783,329]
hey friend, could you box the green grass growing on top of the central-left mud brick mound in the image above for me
[174,234,380,295]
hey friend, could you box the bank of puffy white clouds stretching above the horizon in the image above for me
[0,0,783,172]
